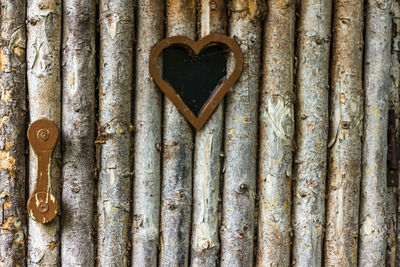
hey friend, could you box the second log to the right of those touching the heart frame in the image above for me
[292,0,331,266]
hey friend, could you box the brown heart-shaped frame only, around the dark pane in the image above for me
[149,33,243,130]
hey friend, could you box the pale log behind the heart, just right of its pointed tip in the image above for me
[191,0,226,266]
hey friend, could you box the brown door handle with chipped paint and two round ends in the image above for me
[27,119,58,223]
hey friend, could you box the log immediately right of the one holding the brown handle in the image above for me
[61,0,96,267]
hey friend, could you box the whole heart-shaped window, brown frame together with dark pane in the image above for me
[149,33,243,130]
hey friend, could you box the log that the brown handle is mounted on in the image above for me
[27,0,62,266]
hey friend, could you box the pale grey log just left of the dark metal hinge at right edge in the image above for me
[359,0,392,266]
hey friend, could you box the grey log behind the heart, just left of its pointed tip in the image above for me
[160,0,197,266]
